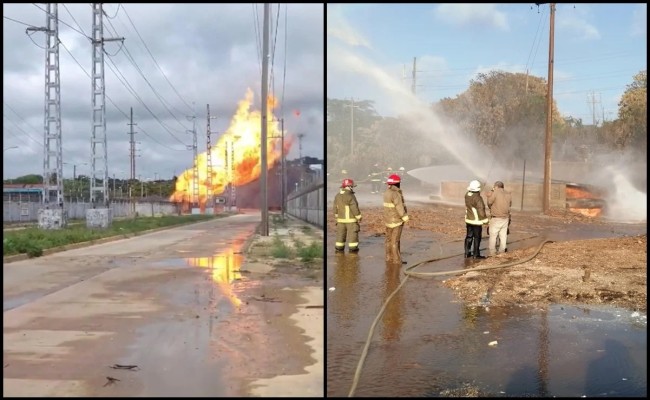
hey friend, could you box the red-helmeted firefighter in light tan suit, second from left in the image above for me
[384,174,409,264]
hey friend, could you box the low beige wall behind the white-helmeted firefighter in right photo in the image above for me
[440,181,566,211]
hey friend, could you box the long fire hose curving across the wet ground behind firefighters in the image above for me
[348,236,553,397]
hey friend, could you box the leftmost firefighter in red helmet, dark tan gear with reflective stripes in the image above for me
[334,178,361,252]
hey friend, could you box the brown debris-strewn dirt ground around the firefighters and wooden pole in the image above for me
[328,203,647,312]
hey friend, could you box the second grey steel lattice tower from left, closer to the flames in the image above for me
[90,3,124,208]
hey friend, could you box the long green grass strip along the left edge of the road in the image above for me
[2,215,220,257]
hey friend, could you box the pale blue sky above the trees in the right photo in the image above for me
[327,3,647,124]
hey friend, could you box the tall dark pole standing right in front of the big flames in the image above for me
[260,3,269,236]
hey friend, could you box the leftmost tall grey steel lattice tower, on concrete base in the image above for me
[27,3,65,217]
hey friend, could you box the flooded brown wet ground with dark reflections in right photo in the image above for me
[326,194,647,397]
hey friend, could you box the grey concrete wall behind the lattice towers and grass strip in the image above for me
[2,202,178,222]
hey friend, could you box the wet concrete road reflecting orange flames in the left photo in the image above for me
[3,211,323,397]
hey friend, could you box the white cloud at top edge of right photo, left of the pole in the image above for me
[434,4,510,31]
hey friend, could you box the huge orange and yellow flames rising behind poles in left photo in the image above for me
[169,89,292,208]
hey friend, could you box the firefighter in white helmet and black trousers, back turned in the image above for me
[465,180,488,259]
